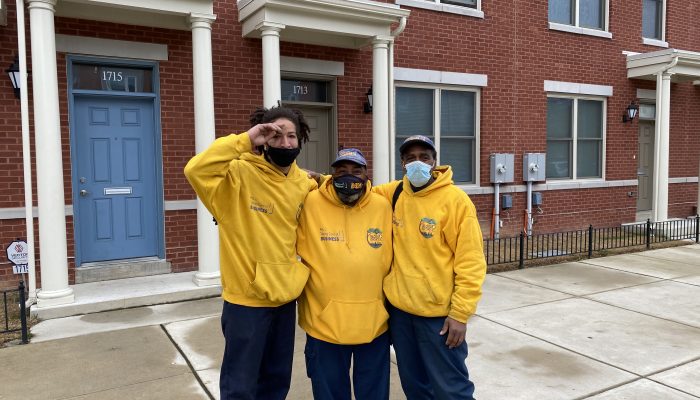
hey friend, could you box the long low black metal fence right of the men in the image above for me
[484,215,700,268]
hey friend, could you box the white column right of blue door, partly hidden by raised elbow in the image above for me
[190,14,220,286]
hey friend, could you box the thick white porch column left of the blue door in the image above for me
[27,0,74,308]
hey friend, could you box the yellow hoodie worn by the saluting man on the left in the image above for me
[185,133,317,307]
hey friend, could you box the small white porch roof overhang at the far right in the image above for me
[627,49,700,82]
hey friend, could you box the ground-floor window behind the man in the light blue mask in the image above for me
[394,87,479,183]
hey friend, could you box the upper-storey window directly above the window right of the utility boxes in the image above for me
[549,0,607,30]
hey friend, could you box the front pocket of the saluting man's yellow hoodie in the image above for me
[246,262,309,303]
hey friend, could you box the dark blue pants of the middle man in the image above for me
[304,332,389,400]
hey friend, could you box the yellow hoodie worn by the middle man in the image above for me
[297,179,392,344]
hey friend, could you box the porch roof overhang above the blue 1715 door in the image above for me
[56,0,214,30]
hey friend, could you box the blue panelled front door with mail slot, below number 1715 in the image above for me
[72,96,160,263]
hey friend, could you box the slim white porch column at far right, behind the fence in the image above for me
[653,72,672,221]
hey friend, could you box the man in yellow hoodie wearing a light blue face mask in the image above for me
[374,135,486,400]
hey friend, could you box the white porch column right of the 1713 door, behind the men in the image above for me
[372,37,391,185]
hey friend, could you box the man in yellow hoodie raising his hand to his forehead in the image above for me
[185,107,317,400]
